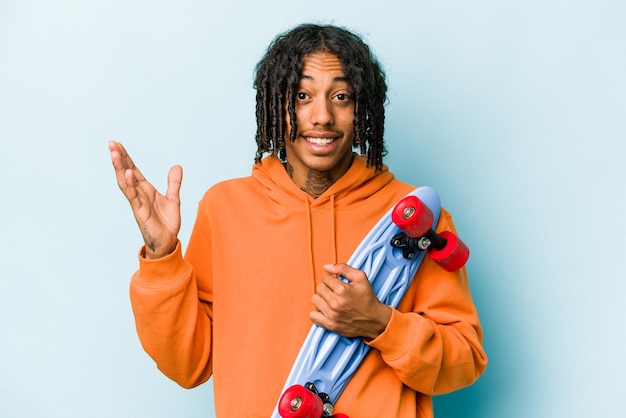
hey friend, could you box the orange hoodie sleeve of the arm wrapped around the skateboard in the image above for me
[368,210,487,395]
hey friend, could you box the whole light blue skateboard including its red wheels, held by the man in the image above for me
[272,187,469,418]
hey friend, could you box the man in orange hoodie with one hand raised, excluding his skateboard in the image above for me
[109,25,487,418]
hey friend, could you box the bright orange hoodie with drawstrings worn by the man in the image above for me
[130,155,487,418]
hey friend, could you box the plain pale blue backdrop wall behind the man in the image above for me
[0,0,626,418]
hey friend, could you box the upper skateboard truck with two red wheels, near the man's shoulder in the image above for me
[391,196,469,271]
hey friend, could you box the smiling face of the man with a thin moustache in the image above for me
[285,52,354,187]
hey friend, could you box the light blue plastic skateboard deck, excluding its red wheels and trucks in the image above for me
[272,187,441,418]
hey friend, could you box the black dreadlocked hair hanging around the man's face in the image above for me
[254,24,387,171]
